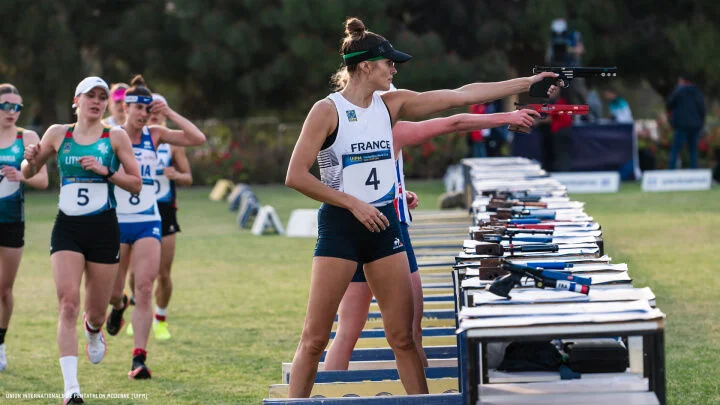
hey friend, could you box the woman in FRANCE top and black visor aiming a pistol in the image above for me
[285,18,557,397]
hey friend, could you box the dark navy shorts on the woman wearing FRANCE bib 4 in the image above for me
[315,204,405,265]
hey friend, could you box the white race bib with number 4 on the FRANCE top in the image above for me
[342,149,395,205]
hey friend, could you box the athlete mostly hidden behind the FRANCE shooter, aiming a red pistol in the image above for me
[324,99,539,370]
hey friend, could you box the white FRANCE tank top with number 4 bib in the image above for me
[318,93,397,207]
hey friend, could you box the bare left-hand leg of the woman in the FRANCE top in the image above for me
[288,256,357,398]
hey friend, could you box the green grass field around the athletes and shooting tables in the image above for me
[0,181,720,405]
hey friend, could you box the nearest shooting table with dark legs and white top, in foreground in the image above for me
[460,316,665,405]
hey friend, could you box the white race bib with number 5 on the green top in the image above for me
[59,177,108,216]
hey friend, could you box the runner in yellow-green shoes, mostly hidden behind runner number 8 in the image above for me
[127,93,192,340]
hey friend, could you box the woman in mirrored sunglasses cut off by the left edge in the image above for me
[0,83,48,371]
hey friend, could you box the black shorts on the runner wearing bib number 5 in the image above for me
[50,209,120,264]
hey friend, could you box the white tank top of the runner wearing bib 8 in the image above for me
[115,127,160,223]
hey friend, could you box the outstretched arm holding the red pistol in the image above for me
[393,109,540,156]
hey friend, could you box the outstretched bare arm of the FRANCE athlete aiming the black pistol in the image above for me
[382,72,558,121]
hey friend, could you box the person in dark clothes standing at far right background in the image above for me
[665,74,705,170]
